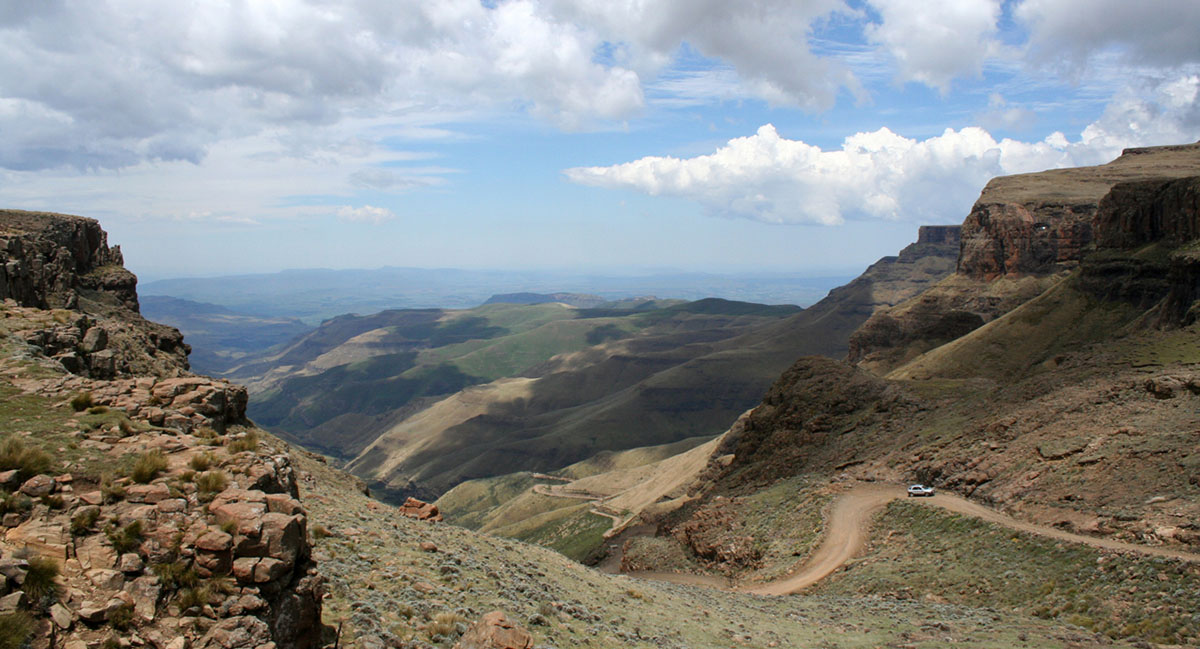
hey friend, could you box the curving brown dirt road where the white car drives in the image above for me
[740,485,1200,595]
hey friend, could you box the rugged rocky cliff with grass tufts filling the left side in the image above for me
[0,211,323,649]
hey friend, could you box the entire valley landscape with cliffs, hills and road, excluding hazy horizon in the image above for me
[0,139,1200,649]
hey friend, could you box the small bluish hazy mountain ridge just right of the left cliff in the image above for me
[140,295,312,374]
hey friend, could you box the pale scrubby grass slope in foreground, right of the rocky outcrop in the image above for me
[298,446,1099,649]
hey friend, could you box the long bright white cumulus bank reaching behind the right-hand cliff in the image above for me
[564,76,1200,226]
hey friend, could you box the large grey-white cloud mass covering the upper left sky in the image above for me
[0,0,643,169]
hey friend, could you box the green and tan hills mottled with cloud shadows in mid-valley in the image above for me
[232,228,959,497]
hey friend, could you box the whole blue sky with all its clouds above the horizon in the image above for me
[0,0,1200,280]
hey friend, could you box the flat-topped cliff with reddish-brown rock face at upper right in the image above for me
[848,144,1200,373]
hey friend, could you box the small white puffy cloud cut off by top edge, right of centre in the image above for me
[866,0,1001,92]
